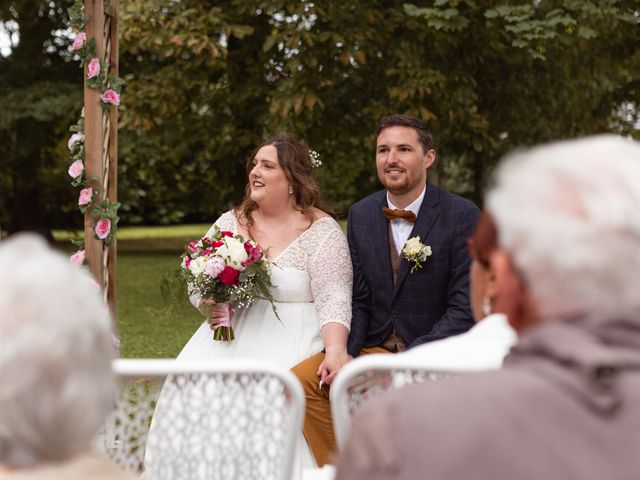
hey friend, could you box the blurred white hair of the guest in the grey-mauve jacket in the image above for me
[487,135,640,318]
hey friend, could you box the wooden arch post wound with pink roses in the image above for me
[84,0,118,320]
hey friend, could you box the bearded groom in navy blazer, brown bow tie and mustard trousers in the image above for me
[293,114,479,466]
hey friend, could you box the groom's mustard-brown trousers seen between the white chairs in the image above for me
[291,347,391,467]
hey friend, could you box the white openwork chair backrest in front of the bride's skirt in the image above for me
[104,359,304,480]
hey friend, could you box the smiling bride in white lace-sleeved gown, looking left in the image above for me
[145,136,352,478]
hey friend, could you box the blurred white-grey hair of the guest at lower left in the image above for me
[0,235,115,469]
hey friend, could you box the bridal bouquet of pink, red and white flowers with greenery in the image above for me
[180,227,277,342]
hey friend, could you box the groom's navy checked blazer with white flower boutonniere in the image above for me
[347,183,479,357]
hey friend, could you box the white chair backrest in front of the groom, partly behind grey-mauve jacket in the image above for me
[331,355,476,449]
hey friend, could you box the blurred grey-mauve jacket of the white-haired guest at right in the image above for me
[336,318,640,480]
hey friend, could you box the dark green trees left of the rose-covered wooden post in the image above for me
[0,0,82,232]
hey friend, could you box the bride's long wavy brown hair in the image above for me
[235,135,335,230]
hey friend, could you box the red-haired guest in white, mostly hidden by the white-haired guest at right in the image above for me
[400,212,518,370]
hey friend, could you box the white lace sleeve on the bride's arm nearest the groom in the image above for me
[309,222,353,329]
